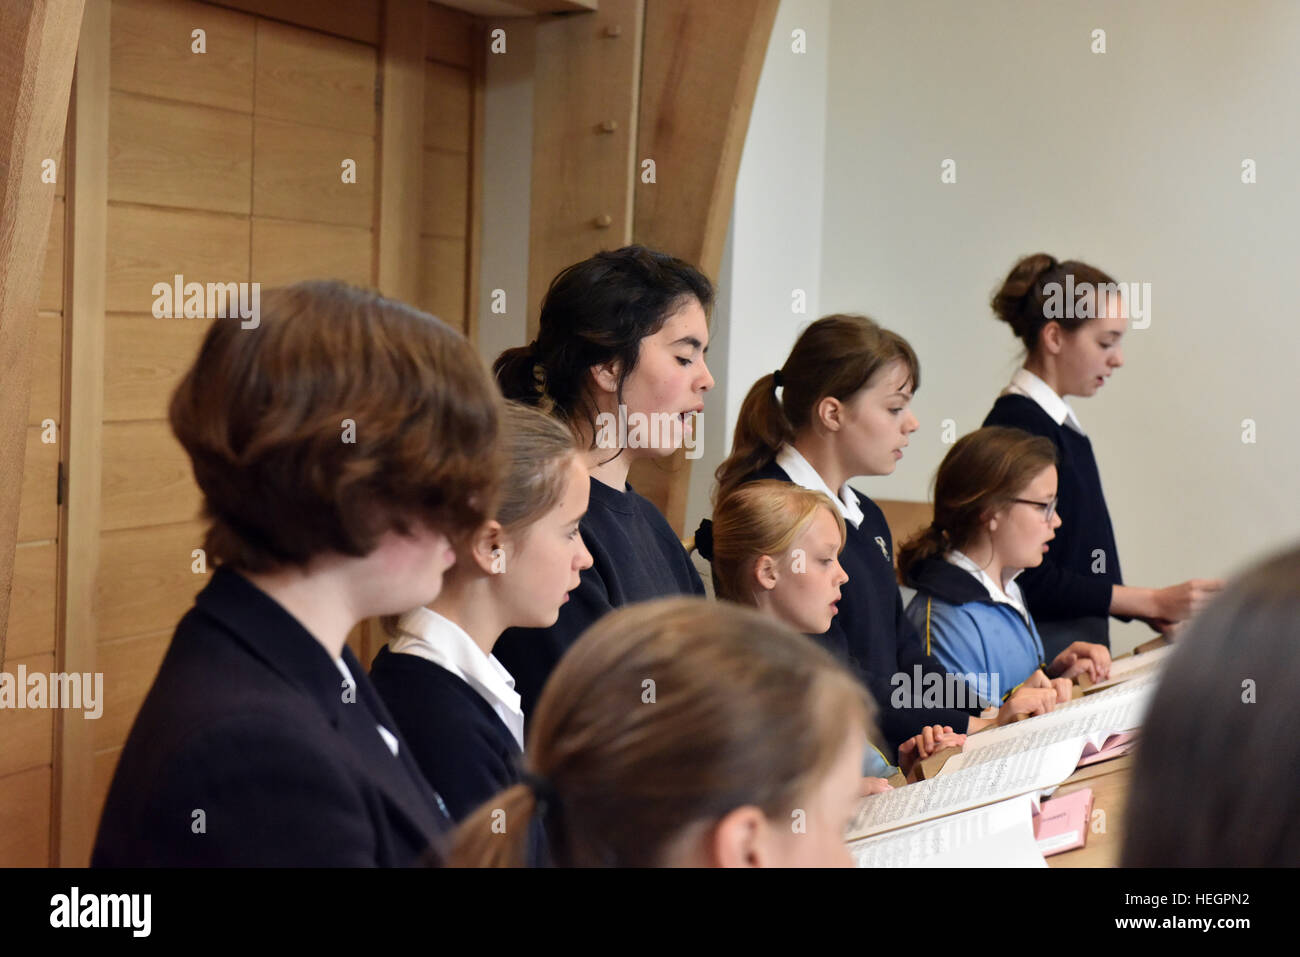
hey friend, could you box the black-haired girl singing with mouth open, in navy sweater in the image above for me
[493,246,714,715]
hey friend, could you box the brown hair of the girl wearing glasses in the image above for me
[898,425,1057,584]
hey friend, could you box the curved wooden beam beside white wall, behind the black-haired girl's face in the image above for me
[629,0,777,536]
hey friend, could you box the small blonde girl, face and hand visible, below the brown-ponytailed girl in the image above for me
[696,479,966,793]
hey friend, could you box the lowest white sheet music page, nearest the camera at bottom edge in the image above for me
[849,794,1047,867]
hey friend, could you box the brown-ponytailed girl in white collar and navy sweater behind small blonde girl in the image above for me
[697,315,980,758]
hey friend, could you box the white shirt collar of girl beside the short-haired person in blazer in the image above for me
[390,609,524,750]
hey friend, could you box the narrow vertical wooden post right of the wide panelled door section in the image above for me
[374,0,429,303]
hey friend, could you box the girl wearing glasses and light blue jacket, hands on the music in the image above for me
[898,426,1110,705]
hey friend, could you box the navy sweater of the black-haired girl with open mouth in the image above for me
[493,479,705,716]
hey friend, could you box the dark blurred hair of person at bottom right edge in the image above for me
[1121,547,1300,867]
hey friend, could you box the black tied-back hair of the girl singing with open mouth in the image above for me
[493,246,714,447]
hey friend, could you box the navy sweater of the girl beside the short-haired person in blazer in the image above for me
[371,648,521,822]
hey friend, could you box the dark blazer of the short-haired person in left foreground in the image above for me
[91,568,450,867]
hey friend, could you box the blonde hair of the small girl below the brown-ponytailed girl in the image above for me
[712,479,846,605]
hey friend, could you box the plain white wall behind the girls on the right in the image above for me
[722,0,1300,650]
